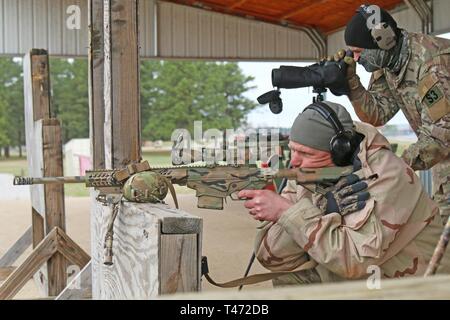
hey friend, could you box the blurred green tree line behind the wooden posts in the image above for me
[0,58,257,157]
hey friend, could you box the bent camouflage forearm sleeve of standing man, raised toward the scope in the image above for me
[349,71,400,127]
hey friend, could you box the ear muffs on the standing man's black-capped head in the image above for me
[357,5,397,50]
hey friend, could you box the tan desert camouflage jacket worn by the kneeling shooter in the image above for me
[255,123,450,285]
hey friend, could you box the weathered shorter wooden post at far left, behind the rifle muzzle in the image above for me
[24,49,66,296]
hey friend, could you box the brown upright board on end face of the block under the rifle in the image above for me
[159,234,200,294]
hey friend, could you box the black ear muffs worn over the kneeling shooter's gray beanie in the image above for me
[303,102,355,167]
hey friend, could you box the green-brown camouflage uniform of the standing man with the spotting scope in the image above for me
[349,33,450,223]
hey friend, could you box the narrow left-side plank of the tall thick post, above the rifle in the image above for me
[88,0,105,169]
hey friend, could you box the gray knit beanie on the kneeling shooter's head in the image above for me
[290,101,354,152]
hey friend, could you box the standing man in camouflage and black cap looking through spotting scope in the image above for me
[340,5,450,223]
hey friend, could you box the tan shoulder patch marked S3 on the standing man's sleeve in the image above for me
[419,74,450,122]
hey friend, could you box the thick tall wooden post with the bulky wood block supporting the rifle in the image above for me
[89,0,201,299]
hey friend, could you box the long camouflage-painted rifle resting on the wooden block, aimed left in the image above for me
[14,161,352,210]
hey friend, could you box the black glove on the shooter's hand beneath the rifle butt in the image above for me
[318,174,370,216]
